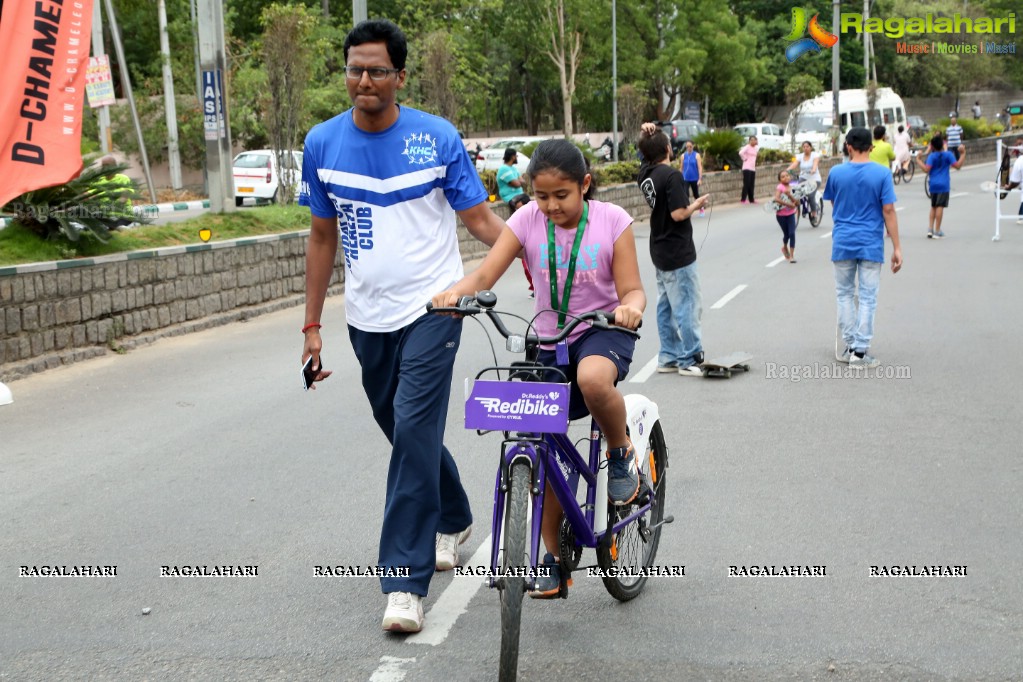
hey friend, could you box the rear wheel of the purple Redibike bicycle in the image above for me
[596,421,668,601]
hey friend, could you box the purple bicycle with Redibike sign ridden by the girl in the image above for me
[428,291,673,680]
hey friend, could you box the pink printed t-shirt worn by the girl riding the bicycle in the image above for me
[507,200,632,343]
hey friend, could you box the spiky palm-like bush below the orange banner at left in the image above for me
[2,164,148,242]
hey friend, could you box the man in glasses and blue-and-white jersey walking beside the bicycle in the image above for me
[299,20,504,632]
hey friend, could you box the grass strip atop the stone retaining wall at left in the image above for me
[0,204,309,266]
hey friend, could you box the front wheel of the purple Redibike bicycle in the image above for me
[498,462,531,682]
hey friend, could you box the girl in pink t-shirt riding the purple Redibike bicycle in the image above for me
[433,140,647,598]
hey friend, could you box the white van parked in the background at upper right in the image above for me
[785,88,907,149]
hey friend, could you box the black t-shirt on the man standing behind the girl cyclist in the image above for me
[639,164,697,270]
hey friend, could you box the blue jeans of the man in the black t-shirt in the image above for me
[657,262,703,368]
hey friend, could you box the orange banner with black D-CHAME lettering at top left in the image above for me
[0,0,93,207]
